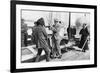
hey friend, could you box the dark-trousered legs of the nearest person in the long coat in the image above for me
[35,48,50,62]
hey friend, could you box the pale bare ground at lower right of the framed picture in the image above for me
[41,51,90,62]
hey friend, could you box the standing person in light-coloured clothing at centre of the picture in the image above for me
[51,19,62,58]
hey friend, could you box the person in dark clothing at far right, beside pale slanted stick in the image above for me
[79,24,89,52]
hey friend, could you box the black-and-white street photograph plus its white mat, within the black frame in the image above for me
[12,2,96,71]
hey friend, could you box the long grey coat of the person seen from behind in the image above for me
[32,25,48,48]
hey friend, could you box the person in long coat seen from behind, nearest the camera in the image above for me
[32,18,50,62]
